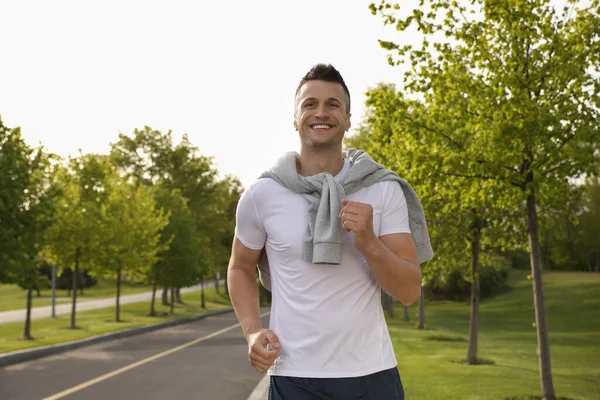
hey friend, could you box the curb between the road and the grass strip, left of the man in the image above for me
[0,308,233,368]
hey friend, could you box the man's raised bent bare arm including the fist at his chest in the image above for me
[340,200,422,306]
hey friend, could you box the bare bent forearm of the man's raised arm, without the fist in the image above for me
[362,239,422,306]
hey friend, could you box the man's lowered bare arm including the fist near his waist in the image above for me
[227,237,279,373]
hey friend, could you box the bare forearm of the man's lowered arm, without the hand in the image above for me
[227,267,262,340]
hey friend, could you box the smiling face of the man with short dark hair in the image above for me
[294,80,350,148]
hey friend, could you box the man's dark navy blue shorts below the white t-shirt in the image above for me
[269,368,404,400]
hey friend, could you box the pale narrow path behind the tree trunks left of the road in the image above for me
[0,281,223,324]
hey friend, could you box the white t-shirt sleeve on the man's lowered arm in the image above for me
[235,186,267,250]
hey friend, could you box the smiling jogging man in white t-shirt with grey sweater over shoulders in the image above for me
[228,64,433,400]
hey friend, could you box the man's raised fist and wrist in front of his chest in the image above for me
[339,200,377,253]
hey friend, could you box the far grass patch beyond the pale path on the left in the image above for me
[0,279,152,312]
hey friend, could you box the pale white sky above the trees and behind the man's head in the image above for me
[0,0,414,186]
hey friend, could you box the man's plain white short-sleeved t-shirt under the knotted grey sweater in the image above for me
[235,161,410,378]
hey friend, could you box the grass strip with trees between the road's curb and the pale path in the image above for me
[0,288,231,353]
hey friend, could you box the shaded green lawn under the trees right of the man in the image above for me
[388,272,600,400]
